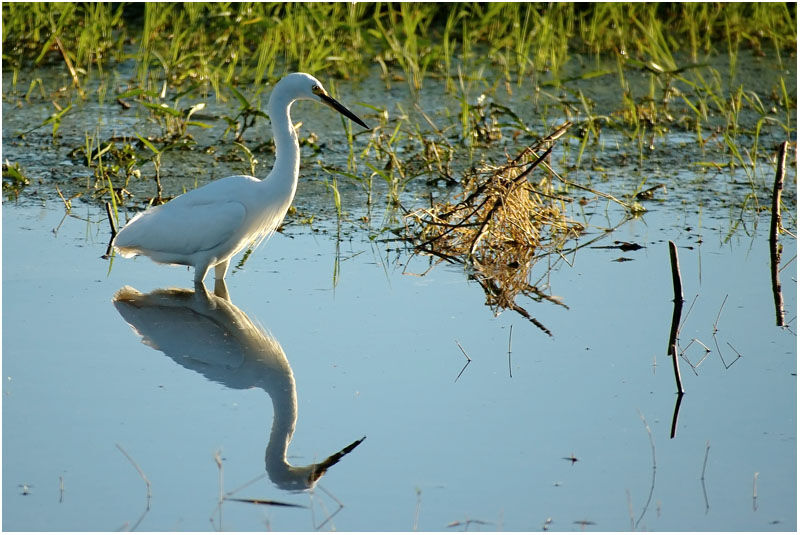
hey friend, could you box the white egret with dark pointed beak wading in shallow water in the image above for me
[112,73,368,284]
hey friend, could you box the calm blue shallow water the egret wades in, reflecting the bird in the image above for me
[2,51,797,531]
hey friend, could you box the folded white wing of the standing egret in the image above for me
[114,201,247,256]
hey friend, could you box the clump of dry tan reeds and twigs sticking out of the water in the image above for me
[404,122,583,334]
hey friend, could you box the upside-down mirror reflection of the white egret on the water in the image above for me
[113,282,366,491]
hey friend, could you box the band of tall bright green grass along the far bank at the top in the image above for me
[3,2,796,92]
